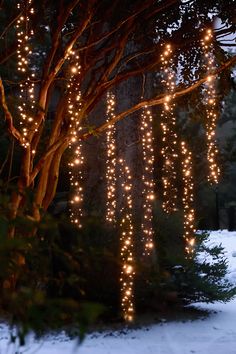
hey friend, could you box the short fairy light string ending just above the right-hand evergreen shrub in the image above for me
[181,141,196,255]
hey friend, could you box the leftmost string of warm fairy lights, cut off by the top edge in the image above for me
[16,0,35,148]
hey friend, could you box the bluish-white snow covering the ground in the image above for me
[0,230,236,354]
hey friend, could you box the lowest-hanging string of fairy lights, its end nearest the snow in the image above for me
[119,159,135,321]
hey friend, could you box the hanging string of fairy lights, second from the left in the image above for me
[67,50,84,228]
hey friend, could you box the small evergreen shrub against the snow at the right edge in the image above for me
[162,233,236,303]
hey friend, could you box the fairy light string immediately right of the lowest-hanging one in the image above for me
[140,106,155,255]
